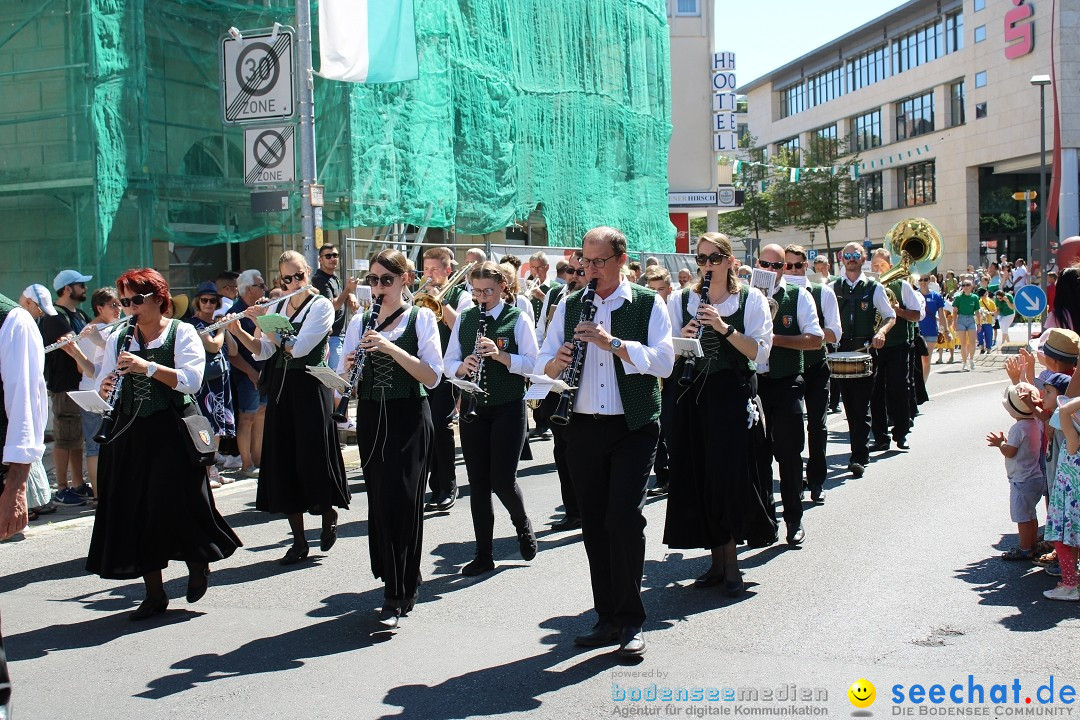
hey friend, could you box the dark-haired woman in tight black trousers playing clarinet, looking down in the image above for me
[443,262,539,576]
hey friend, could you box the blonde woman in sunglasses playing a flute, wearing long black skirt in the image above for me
[229,250,349,565]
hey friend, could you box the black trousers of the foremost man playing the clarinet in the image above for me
[565,412,660,627]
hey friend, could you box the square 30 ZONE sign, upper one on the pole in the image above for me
[221,28,296,124]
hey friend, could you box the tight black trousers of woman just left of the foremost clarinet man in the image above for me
[458,400,529,557]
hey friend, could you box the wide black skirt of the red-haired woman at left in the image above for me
[86,408,242,580]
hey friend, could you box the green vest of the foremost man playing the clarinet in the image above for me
[563,283,660,431]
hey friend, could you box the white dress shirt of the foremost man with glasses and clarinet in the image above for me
[536,279,675,415]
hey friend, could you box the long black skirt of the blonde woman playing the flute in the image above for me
[255,368,349,515]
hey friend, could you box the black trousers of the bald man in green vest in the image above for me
[757,376,806,528]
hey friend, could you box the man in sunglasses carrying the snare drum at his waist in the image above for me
[833,243,896,477]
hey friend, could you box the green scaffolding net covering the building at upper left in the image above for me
[0,0,674,294]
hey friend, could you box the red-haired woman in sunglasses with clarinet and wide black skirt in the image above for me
[86,268,241,620]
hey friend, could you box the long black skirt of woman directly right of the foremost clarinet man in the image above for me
[664,370,777,549]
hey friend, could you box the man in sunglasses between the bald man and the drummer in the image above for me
[784,244,843,503]
